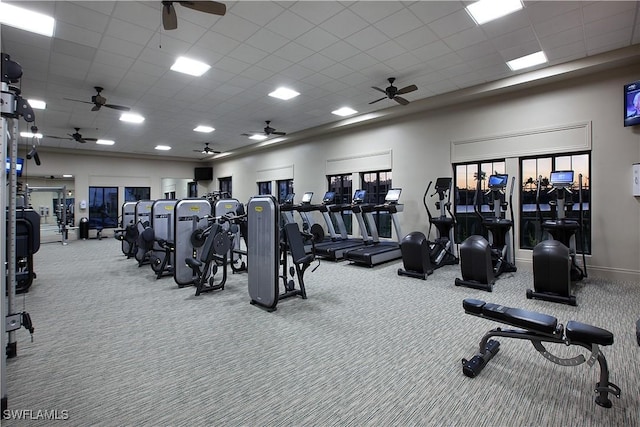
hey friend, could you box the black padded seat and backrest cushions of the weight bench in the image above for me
[462,298,613,346]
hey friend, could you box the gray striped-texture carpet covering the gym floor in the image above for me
[2,239,640,426]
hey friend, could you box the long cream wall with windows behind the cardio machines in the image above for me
[214,65,640,280]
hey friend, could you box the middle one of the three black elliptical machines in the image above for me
[455,174,517,292]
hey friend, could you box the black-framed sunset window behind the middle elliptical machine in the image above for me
[453,160,506,243]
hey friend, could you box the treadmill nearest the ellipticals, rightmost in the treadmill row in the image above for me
[344,188,404,267]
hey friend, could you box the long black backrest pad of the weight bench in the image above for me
[462,299,558,334]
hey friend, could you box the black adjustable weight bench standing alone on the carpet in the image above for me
[462,298,620,408]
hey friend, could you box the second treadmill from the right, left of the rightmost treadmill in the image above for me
[316,190,373,261]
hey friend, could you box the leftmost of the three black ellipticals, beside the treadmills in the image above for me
[398,177,459,280]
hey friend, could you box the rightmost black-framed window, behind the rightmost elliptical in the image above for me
[520,153,591,254]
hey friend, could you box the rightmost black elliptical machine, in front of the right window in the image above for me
[526,170,587,305]
